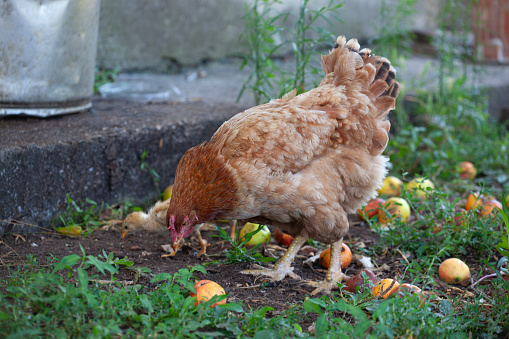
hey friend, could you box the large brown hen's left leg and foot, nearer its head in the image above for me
[240,230,308,280]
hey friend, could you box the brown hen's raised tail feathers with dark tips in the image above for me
[321,36,400,154]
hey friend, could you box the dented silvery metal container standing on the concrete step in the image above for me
[0,0,100,117]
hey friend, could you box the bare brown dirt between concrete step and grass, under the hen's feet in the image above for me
[0,217,492,322]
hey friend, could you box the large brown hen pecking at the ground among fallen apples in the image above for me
[167,36,399,294]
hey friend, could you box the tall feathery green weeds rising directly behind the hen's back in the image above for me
[237,0,342,105]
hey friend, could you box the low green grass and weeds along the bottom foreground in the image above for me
[0,253,509,338]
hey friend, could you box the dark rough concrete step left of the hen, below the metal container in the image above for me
[0,100,242,233]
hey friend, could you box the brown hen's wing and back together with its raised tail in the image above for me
[211,37,398,173]
